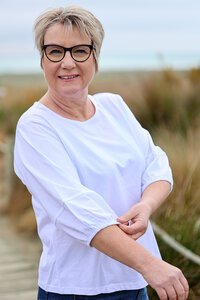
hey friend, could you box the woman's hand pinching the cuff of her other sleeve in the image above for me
[117,202,151,240]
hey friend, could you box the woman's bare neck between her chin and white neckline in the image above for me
[40,91,95,121]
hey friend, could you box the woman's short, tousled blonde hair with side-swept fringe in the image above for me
[34,6,104,71]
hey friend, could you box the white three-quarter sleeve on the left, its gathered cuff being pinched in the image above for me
[14,118,117,245]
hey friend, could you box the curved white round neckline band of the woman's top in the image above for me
[35,95,98,124]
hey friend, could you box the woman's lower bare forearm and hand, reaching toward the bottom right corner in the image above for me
[91,225,189,300]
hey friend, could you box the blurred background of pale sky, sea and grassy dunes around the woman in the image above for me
[0,0,200,300]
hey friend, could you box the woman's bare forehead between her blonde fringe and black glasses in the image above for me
[44,23,91,47]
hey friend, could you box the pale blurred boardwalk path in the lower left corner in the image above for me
[0,216,41,300]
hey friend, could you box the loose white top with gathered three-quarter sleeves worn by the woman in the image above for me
[14,93,172,295]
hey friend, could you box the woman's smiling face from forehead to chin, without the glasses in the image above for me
[42,24,95,99]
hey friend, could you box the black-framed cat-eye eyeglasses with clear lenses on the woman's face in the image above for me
[42,45,94,62]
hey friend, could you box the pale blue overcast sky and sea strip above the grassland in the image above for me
[0,0,200,73]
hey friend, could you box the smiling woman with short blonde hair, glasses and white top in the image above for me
[14,7,188,300]
